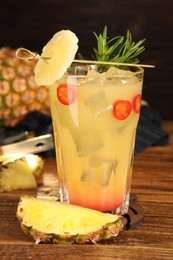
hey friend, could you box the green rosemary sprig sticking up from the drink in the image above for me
[92,26,145,64]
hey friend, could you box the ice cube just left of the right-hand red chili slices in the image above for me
[84,91,112,116]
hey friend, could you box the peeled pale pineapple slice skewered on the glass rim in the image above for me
[34,30,78,85]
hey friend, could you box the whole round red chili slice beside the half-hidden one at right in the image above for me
[112,100,132,120]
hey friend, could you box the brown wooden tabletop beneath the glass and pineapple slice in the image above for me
[0,121,173,260]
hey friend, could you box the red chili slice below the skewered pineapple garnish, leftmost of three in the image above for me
[57,83,76,105]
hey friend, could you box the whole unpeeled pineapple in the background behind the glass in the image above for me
[0,47,50,126]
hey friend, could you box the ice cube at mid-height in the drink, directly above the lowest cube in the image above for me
[70,127,104,156]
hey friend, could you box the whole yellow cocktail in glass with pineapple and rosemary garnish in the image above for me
[31,27,147,214]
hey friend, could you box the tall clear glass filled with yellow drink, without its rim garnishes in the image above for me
[49,64,144,214]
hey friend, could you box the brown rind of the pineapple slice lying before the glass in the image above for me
[16,197,123,244]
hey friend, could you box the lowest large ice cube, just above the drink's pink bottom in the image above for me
[81,156,118,186]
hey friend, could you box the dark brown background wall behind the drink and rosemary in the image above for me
[0,0,173,119]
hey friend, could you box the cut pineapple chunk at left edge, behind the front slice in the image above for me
[0,154,44,192]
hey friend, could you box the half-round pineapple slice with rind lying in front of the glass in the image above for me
[16,196,123,244]
